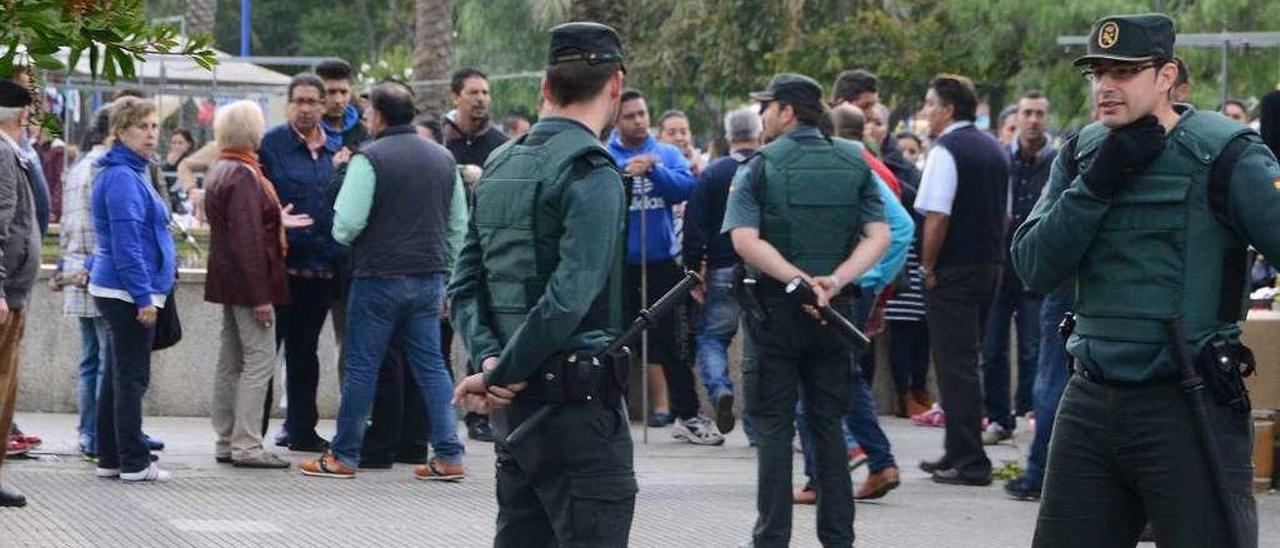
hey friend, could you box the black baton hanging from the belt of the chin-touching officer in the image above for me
[1165,316,1240,548]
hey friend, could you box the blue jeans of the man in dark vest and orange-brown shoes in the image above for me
[332,273,465,467]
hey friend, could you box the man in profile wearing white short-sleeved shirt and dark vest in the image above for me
[915,74,1009,485]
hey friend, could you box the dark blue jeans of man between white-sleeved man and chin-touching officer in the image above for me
[982,280,1044,431]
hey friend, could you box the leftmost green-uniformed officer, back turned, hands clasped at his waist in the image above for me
[449,23,636,547]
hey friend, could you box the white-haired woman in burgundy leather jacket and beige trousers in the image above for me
[205,101,311,469]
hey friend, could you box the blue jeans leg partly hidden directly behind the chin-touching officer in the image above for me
[1024,287,1075,485]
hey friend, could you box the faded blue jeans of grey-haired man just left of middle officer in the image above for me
[696,266,742,402]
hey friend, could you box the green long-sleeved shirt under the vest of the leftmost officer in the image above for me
[449,118,626,385]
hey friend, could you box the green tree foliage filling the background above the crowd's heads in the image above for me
[150,0,1280,136]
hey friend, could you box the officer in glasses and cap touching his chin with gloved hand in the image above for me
[1012,14,1280,548]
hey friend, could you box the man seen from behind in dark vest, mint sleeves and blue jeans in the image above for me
[300,83,466,480]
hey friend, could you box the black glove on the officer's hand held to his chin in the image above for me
[1084,114,1165,198]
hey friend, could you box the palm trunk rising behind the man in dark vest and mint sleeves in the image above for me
[413,0,453,117]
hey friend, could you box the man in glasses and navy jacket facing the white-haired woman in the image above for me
[257,73,338,452]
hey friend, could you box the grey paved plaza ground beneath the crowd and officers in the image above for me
[0,414,1280,548]
